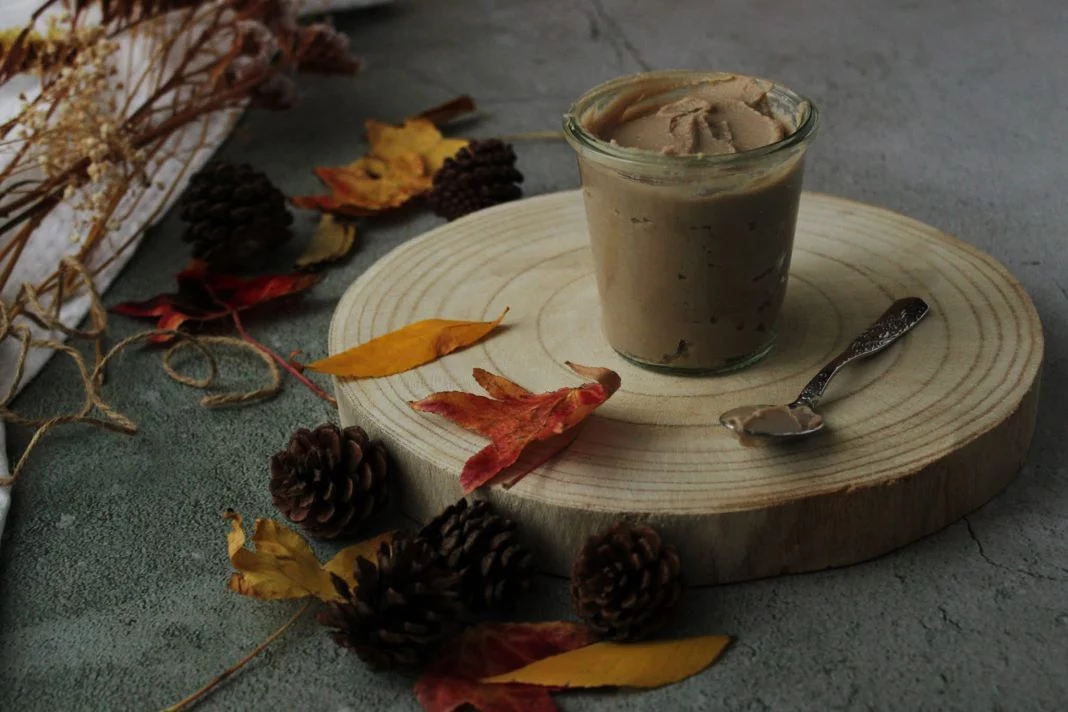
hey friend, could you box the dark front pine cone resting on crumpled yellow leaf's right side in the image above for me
[319,534,464,668]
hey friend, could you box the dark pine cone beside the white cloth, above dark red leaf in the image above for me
[182,161,293,272]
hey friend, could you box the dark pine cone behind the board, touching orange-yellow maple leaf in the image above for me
[428,139,523,220]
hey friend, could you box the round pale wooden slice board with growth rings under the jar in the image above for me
[330,191,1042,584]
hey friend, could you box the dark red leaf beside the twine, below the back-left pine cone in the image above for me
[111,260,319,344]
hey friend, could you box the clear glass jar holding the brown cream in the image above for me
[564,72,819,374]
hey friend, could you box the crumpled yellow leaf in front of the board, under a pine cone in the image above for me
[224,509,393,601]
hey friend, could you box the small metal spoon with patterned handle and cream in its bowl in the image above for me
[720,297,930,444]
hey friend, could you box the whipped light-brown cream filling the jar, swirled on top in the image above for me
[565,73,811,371]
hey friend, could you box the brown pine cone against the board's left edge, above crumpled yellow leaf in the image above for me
[270,423,389,539]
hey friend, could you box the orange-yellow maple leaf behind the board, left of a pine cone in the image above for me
[293,116,469,216]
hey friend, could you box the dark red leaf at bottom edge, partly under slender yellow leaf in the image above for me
[415,620,593,712]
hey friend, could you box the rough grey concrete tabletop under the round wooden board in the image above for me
[0,0,1068,711]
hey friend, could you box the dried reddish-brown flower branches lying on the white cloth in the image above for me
[0,0,358,305]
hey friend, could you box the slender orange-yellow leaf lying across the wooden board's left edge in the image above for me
[308,308,508,378]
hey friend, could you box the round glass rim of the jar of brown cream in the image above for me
[563,69,819,168]
